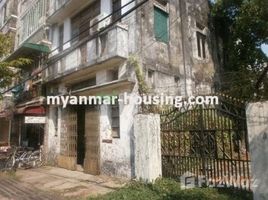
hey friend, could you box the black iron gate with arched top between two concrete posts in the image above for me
[161,94,250,190]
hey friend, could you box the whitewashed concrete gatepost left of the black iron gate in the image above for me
[134,114,162,182]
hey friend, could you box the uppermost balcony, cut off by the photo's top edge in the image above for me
[47,0,94,24]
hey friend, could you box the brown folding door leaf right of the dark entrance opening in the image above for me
[84,107,100,175]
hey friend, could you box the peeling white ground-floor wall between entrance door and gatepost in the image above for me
[100,94,137,178]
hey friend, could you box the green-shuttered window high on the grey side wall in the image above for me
[154,7,169,43]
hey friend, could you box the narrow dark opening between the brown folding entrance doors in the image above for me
[77,106,85,166]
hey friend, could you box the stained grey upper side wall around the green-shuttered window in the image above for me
[136,0,219,96]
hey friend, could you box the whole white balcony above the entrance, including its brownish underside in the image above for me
[45,24,128,81]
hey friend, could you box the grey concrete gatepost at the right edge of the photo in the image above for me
[247,101,268,200]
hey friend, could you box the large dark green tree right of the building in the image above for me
[212,0,268,100]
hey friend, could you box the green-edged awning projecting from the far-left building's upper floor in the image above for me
[5,42,50,61]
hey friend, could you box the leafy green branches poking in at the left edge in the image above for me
[0,33,31,97]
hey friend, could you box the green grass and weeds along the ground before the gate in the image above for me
[89,179,253,200]
